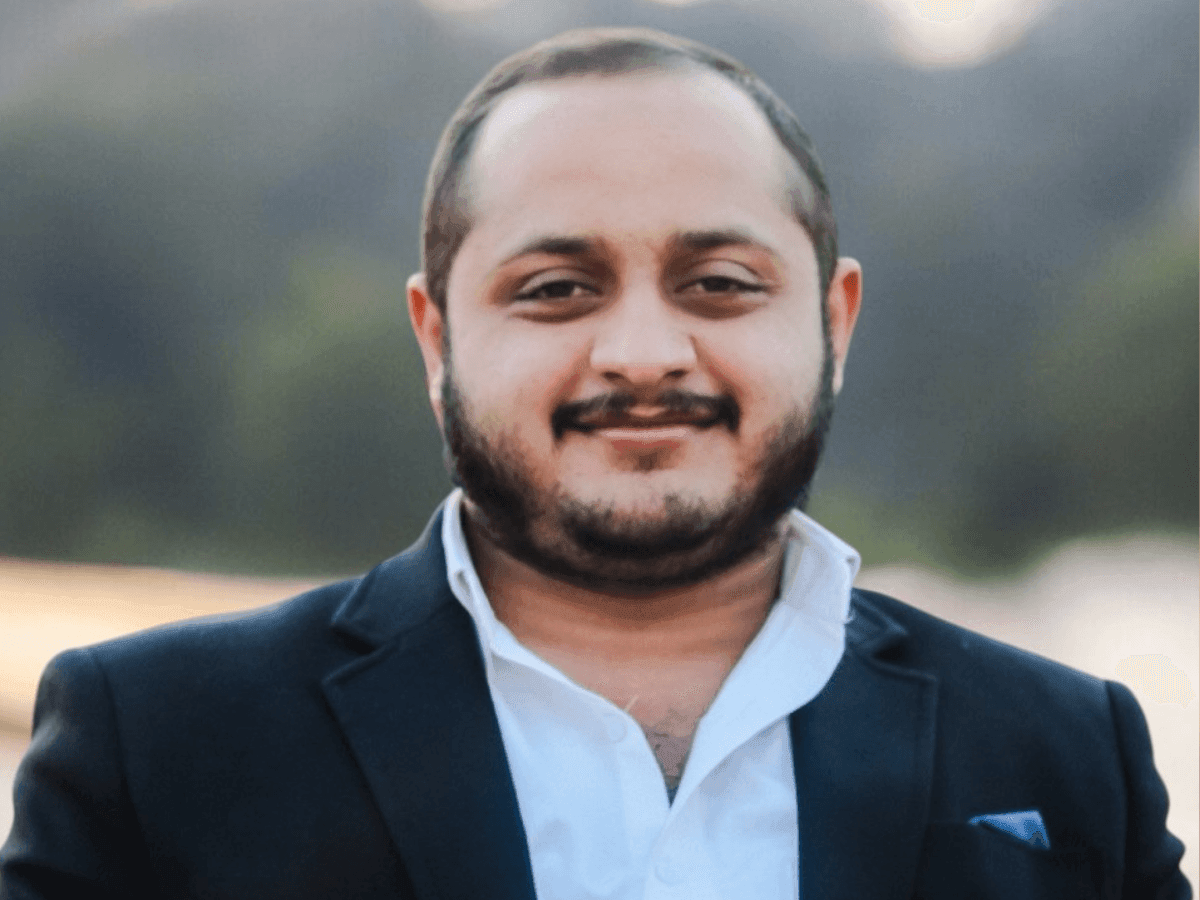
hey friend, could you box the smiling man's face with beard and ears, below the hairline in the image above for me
[409,71,858,593]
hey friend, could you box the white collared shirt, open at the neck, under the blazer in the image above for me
[442,491,859,900]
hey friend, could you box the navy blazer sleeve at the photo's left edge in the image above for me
[0,649,150,900]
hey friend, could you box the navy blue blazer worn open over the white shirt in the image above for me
[0,514,1190,900]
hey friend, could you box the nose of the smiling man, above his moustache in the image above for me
[592,286,696,389]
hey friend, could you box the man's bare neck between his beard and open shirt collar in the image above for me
[463,504,784,666]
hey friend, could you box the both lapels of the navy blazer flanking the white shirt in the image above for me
[323,509,937,900]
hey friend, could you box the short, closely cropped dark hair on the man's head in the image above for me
[421,28,838,314]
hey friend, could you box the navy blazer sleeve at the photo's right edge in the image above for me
[1106,682,1192,900]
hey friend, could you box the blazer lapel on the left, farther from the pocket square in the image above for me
[323,511,534,900]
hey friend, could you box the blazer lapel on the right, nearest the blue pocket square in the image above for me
[790,590,937,900]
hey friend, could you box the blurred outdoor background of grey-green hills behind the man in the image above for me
[0,0,1200,881]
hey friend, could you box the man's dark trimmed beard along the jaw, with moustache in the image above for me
[442,335,834,595]
